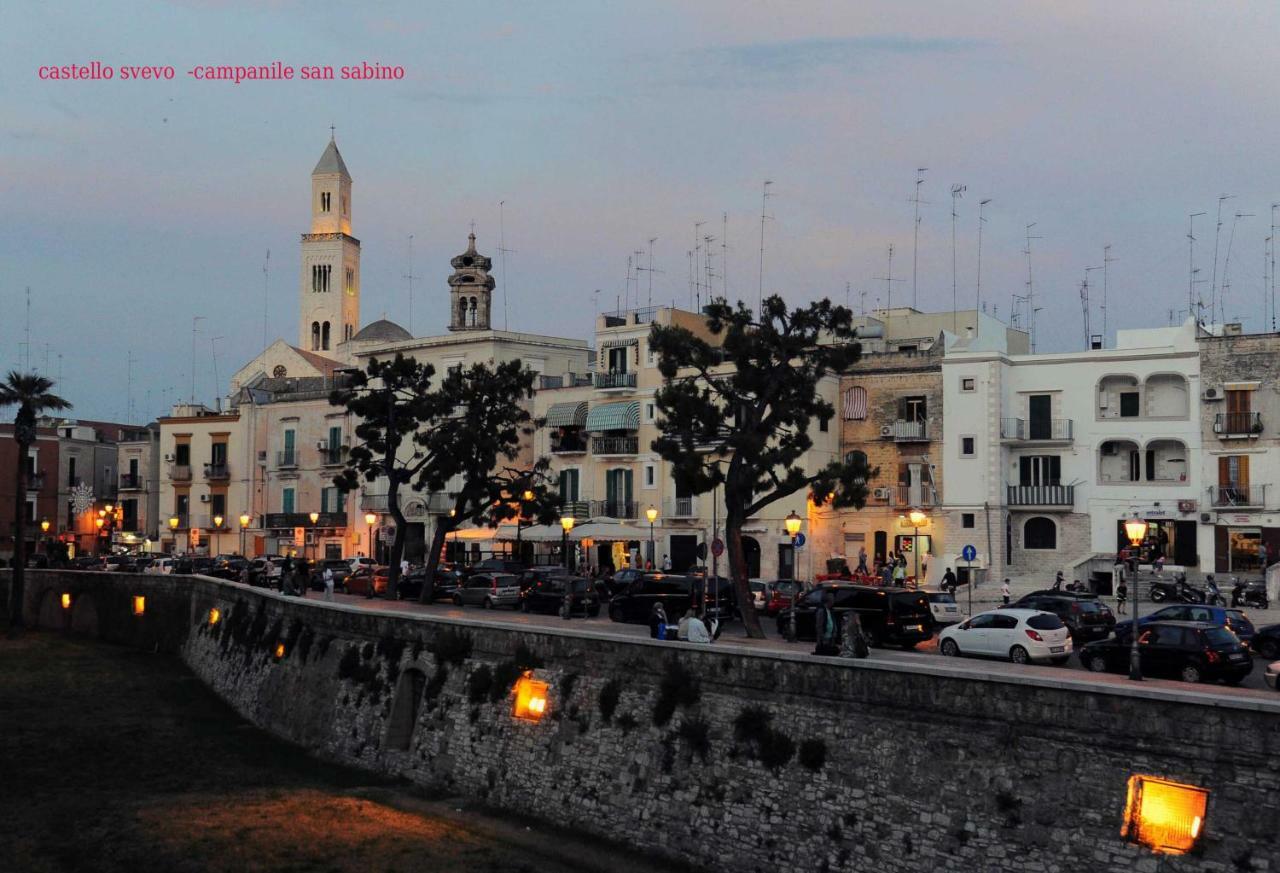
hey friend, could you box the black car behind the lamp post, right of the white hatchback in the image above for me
[1080,621,1253,685]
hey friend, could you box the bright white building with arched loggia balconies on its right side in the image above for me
[942,321,1212,582]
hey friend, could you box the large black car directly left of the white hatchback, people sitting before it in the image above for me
[778,582,933,649]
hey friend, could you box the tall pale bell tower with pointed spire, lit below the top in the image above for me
[298,133,360,353]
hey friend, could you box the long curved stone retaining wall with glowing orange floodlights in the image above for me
[5,571,1280,873]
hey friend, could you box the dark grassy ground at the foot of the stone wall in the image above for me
[0,631,662,873]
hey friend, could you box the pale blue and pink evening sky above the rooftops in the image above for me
[0,0,1280,421]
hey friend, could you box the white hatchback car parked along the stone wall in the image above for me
[938,609,1071,664]
